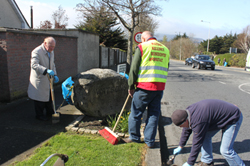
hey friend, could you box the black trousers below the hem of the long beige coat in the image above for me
[33,96,54,117]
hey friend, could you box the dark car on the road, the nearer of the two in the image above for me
[192,55,215,70]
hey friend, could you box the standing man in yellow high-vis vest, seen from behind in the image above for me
[124,31,170,148]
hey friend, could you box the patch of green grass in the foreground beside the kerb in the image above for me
[15,132,145,166]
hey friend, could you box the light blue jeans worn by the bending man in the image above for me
[201,114,245,166]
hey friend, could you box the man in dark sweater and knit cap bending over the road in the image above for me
[171,99,245,166]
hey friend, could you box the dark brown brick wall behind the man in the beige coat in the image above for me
[0,30,77,101]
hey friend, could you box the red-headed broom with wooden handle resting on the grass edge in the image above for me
[99,94,129,145]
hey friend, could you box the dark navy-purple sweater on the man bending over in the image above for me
[179,99,241,165]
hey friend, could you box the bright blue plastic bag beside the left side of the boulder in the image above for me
[62,77,74,104]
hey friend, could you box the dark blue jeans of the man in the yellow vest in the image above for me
[128,89,163,146]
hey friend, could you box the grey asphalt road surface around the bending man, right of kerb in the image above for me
[162,61,250,166]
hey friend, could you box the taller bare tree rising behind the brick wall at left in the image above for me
[52,6,69,29]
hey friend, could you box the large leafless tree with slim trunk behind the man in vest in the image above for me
[77,0,167,65]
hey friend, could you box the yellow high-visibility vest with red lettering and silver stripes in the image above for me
[137,40,170,83]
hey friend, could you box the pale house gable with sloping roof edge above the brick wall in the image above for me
[0,0,30,29]
